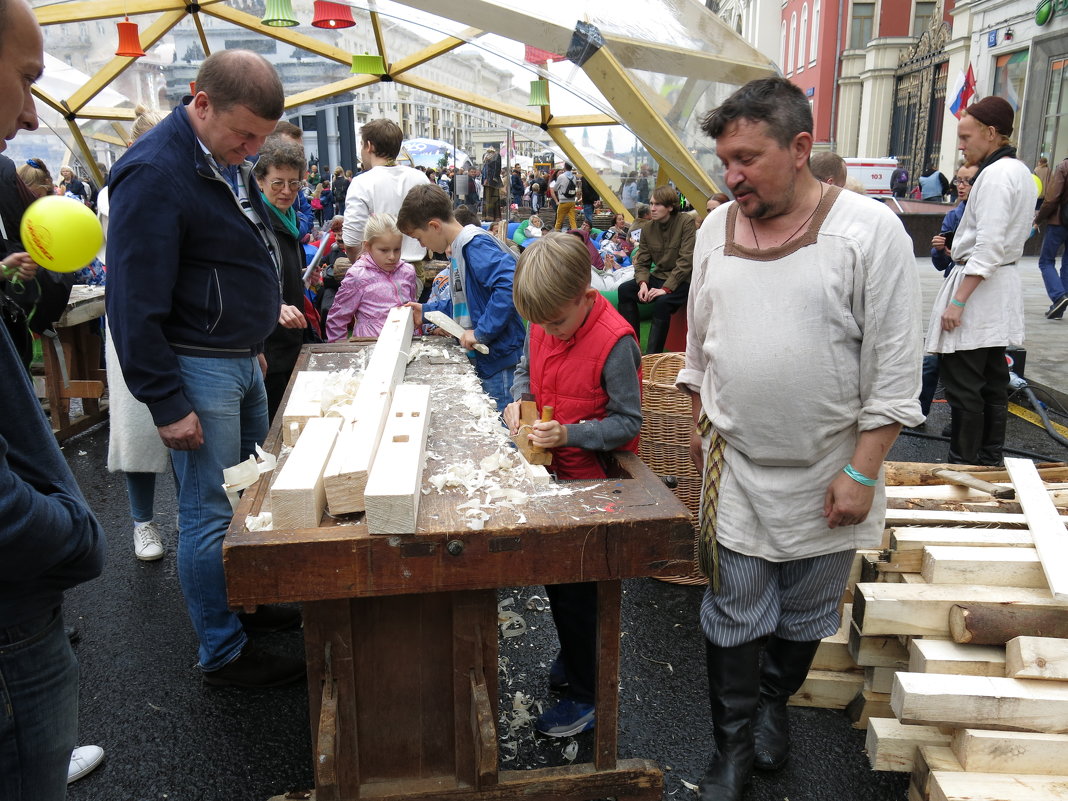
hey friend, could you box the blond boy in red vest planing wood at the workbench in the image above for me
[504,234,642,737]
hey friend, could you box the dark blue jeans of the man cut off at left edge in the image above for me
[0,608,78,801]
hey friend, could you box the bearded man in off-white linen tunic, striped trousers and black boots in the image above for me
[678,78,923,801]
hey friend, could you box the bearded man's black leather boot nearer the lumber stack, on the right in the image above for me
[753,637,819,770]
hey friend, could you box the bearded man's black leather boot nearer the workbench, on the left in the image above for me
[697,640,764,801]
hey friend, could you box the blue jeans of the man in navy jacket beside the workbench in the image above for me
[171,356,267,671]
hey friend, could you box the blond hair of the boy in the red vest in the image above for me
[512,233,591,323]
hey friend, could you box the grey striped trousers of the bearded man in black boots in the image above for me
[701,544,855,647]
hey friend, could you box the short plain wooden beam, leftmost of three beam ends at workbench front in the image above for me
[270,418,341,531]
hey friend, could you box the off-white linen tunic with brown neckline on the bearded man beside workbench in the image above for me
[677,188,924,562]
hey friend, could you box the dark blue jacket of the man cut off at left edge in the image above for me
[0,326,106,626]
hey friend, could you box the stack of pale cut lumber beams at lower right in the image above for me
[848,459,1068,801]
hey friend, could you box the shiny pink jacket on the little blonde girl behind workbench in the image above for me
[327,253,419,342]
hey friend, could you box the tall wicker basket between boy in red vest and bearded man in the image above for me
[638,354,706,585]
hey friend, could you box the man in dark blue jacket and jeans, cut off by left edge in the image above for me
[0,0,105,801]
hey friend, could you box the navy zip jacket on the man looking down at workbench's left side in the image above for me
[106,106,282,426]
